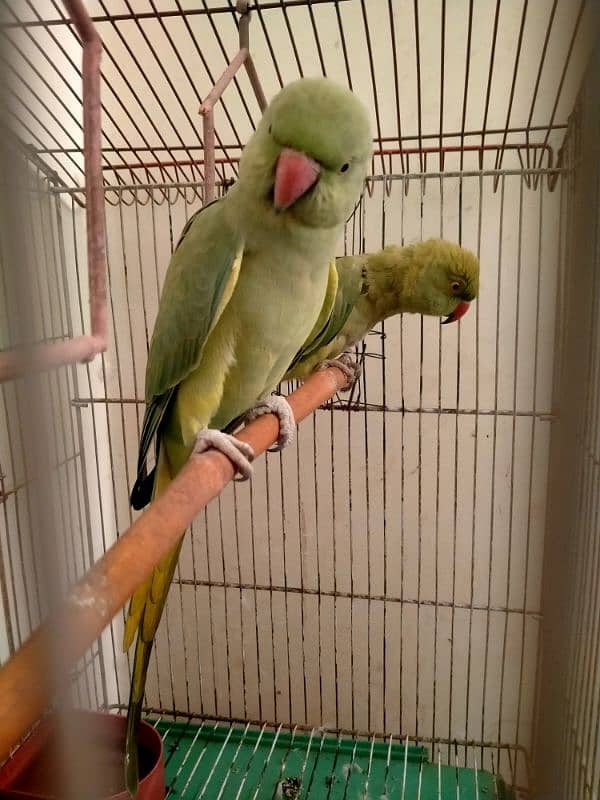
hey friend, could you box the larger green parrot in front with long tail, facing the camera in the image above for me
[123,78,372,796]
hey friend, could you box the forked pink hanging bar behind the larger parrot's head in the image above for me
[200,0,267,204]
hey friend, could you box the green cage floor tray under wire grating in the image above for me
[156,721,514,800]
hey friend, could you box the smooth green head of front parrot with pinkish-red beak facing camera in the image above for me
[239,78,372,228]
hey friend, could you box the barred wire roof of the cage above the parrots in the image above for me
[3,0,595,185]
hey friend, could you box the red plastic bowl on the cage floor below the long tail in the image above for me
[0,711,165,800]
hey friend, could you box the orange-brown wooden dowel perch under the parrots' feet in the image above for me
[0,367,346,761]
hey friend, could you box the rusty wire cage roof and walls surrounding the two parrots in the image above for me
[0,0,600,798]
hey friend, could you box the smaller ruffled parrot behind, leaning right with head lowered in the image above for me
[285,239,479,379]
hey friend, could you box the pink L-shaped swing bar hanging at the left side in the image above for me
[0,0,108,382]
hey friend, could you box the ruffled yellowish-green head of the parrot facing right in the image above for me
[410,239,479,325]
